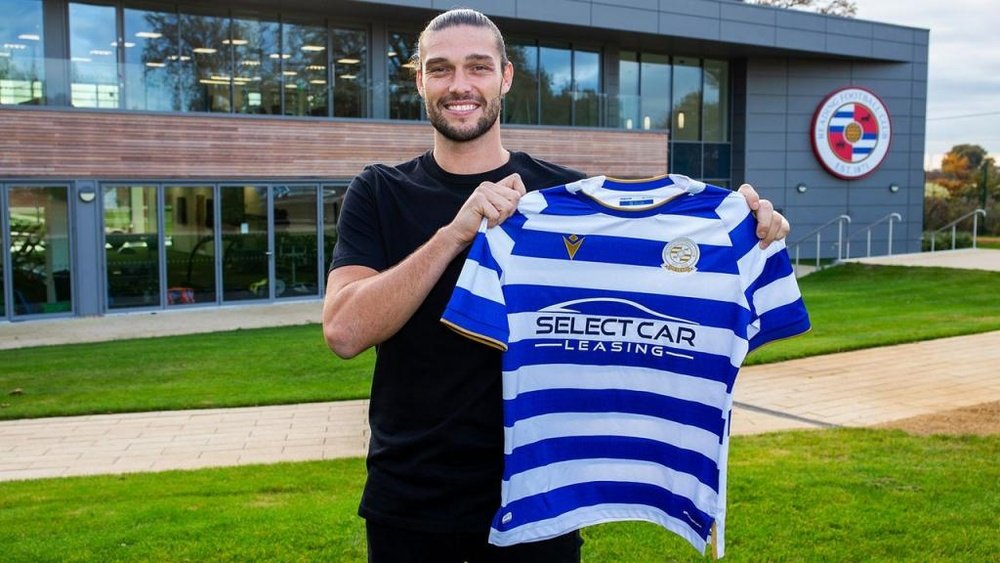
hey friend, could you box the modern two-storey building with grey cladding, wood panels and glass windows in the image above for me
[0,0,928,322]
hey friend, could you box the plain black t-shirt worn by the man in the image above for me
[331,152,584,537]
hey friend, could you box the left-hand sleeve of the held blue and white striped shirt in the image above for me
[441,220,510,350]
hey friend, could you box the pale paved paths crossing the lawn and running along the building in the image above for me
[0,251,1000,481]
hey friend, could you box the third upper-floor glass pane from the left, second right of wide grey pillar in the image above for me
[125,8,180,111]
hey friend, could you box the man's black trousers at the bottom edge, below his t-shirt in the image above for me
[365,521,583,563]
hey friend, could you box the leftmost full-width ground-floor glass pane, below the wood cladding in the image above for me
[7,186,72,315]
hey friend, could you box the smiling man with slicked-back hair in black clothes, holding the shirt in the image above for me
[323,9,788,562]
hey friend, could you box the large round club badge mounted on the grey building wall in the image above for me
[812,88,892,180]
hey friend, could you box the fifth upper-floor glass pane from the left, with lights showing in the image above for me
[229,18,281,115]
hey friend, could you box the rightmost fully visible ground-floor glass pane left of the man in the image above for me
[272,186,319,298]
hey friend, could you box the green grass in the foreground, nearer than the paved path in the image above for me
[0,429,1000,563]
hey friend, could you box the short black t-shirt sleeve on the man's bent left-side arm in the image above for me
[330,170,389,272]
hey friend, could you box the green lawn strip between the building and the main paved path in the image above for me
[0,264,1000,420]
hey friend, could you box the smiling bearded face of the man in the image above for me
[417,26,513,142]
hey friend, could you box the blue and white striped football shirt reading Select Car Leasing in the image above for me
[442,175,809,555]
